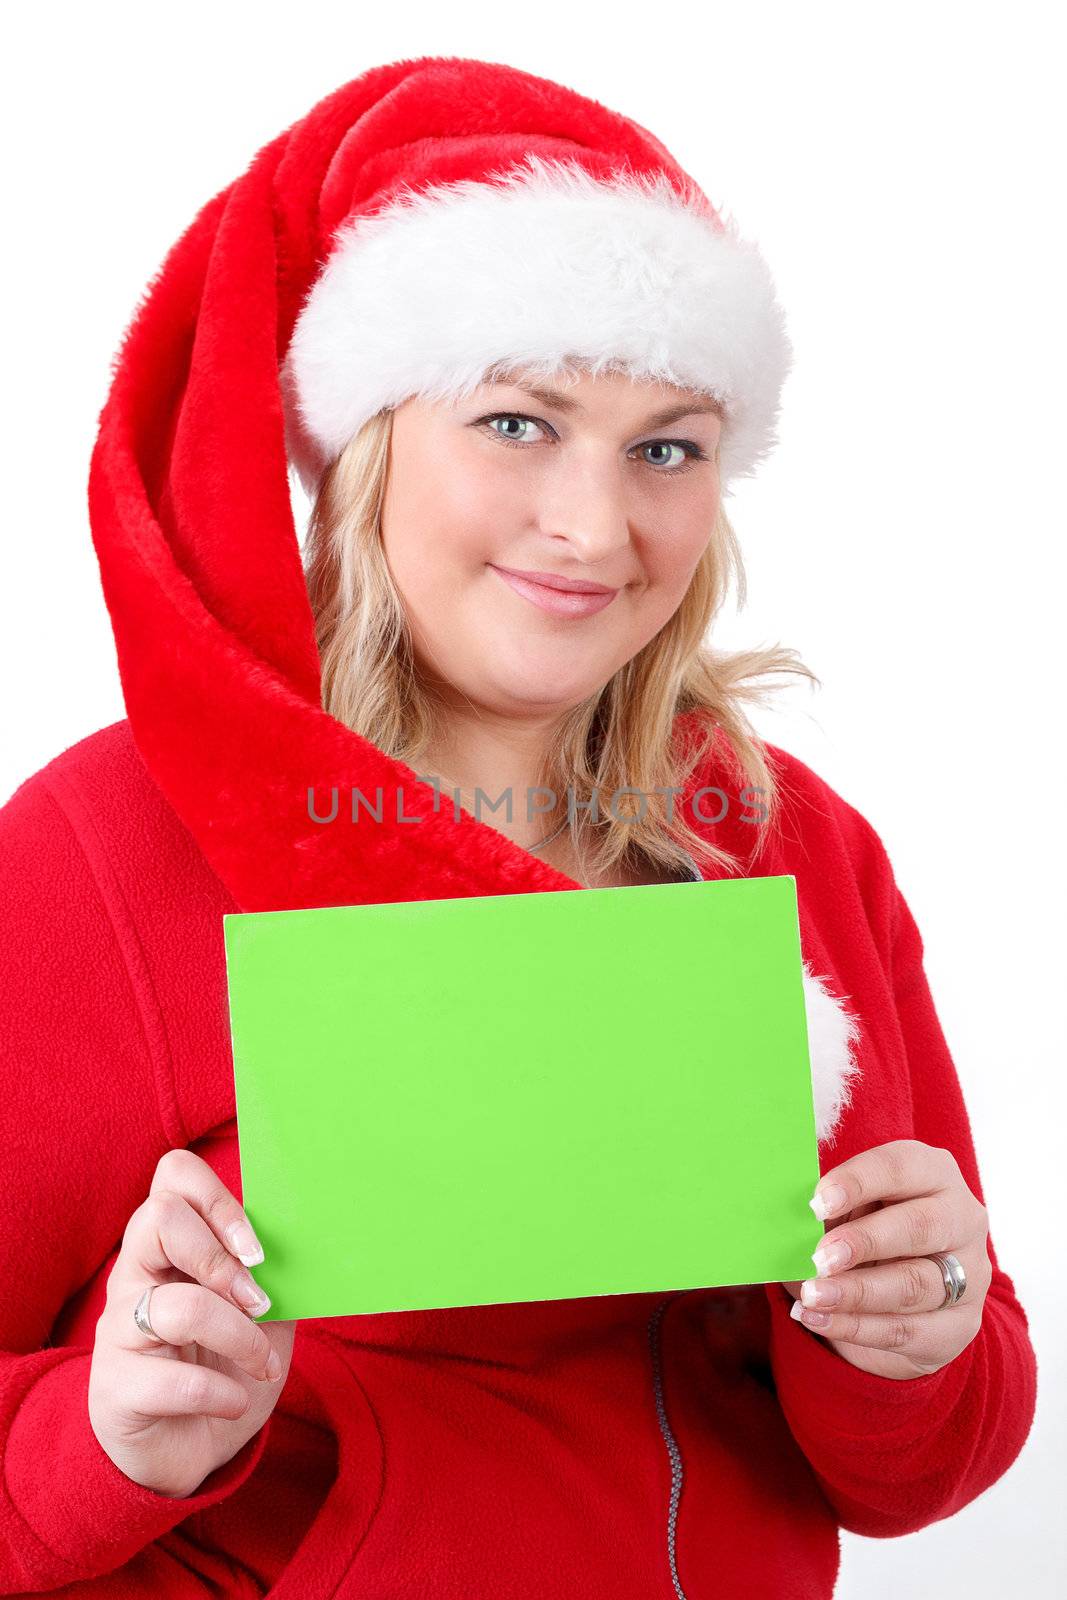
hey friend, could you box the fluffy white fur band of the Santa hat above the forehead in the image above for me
[280,152,792,496]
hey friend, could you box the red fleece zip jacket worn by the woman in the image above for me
[0,722,1037,1600]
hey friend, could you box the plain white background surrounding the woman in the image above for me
[0,0,1067,1600]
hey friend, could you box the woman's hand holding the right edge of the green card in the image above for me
[785,1139,993,1378]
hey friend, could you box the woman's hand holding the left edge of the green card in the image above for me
[88,1149,296,1496]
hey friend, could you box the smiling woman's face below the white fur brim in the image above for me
[382,371,721,717]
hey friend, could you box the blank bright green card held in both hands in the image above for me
[224,877,822,1322]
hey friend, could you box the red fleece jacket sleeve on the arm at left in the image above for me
[0,779,270,1595]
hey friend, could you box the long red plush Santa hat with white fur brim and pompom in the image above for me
[90,58,848,1131]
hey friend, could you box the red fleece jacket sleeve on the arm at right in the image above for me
[765,838,1037,1538]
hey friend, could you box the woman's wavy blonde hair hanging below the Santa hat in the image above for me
[304,400,819,877]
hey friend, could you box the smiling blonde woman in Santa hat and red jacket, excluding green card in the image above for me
[0,58,1035,1600]
